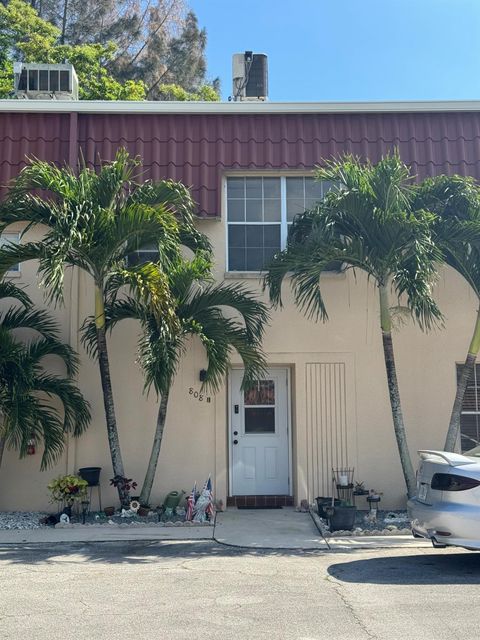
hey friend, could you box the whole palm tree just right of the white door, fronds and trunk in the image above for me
[265,153,441,496]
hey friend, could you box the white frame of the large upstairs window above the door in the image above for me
[222,170,330,277]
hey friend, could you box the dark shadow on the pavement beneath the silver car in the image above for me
[328,549,480,585]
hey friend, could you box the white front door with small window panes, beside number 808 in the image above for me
[230,369,290,496]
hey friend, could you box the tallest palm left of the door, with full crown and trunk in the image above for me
[0,149,208,505]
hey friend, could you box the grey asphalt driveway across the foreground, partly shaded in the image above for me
[0,541,480,640]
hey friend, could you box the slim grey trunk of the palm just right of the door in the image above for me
[379,285,416,498]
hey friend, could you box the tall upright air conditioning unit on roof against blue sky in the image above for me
[232,51,268,101]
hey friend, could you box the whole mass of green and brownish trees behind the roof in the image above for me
[0,0,219,101]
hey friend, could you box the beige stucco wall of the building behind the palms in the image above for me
[0,220,476,510]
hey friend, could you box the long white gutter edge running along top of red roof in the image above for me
[0,100,480,115]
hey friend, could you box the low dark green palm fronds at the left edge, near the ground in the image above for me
[0,282,90,470]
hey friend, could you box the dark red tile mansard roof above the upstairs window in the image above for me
[0,105,480,216]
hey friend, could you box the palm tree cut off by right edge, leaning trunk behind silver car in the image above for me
[417,176,480,451]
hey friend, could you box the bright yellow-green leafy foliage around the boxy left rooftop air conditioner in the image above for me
[0,0,146,100]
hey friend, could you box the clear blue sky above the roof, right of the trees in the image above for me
[189,0,480,101]
